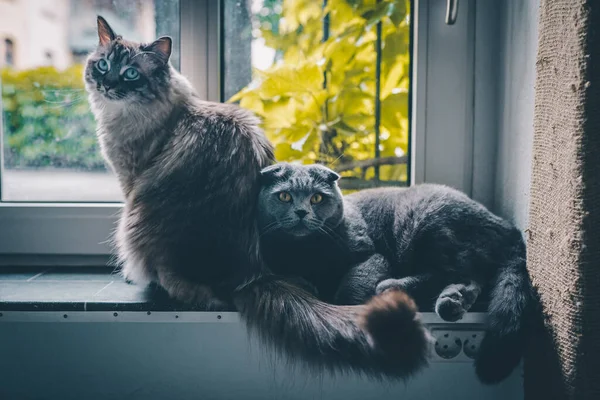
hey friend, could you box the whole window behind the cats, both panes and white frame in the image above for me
[0,0,494,264]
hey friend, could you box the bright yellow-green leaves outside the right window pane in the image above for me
[229,0,410,184]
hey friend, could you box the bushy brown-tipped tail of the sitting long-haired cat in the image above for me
[235,277,430,379]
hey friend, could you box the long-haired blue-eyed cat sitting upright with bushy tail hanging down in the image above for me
[85,17,429,378]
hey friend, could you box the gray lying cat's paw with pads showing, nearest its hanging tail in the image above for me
[435,281,481,322]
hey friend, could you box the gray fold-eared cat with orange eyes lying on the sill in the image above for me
[258,163,532,383]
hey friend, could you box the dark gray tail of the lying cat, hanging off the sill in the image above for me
[475,242,534,384]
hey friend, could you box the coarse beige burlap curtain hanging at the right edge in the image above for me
[524,0,600,399]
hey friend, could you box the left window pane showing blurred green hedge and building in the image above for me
[0,0,179,202]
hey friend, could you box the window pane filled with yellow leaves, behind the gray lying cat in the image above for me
[223,0,411,190]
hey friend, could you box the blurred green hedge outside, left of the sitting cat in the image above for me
[0,65,104,170]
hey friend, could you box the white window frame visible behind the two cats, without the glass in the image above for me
[0,0,495,265]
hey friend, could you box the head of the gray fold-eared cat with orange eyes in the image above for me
[258,164,344,238]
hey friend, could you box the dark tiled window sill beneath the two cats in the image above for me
[0,267,486,324]
